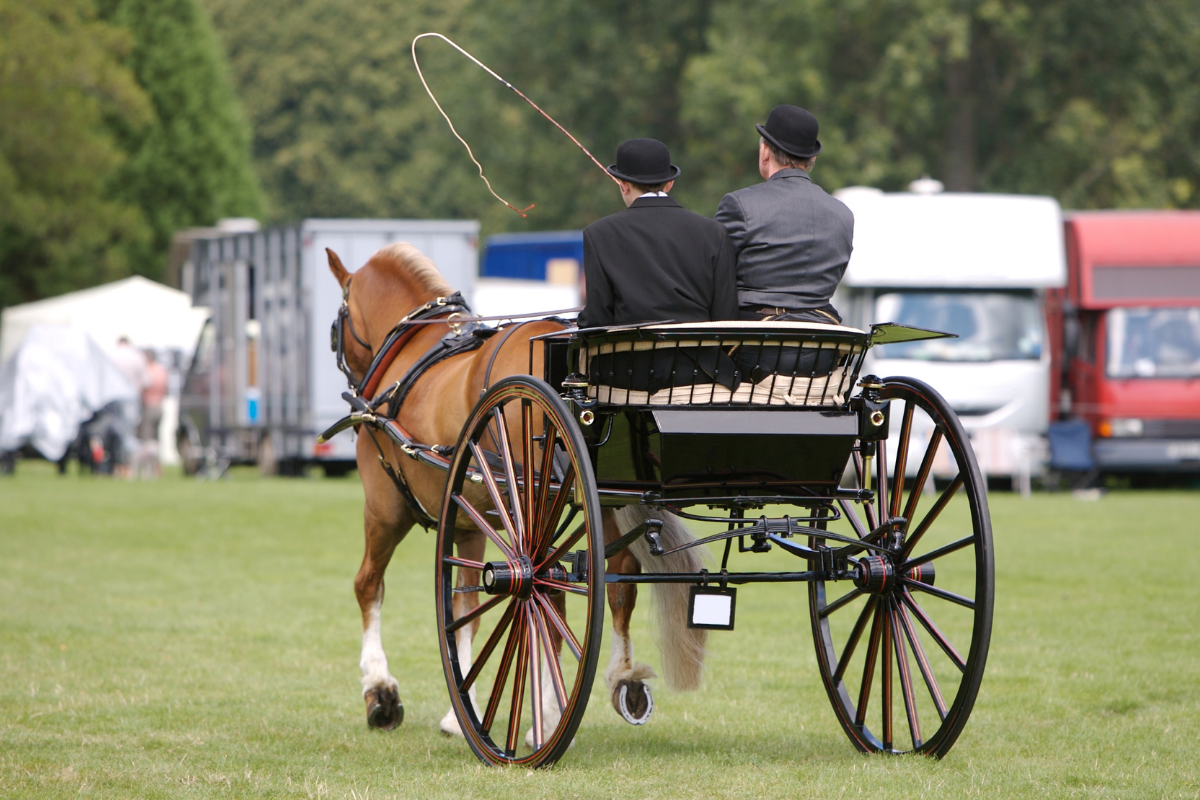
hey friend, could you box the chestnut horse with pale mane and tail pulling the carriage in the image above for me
[329,243,704,745]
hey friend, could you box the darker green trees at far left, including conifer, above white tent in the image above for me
[0,0,263,307]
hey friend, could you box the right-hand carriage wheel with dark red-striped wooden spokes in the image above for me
[809,378,994,758]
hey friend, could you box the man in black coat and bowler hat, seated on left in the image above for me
[580,139,738,391]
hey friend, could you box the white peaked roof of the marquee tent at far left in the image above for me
[0,276,209,363]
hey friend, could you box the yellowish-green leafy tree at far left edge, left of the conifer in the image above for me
[0,0,150,306]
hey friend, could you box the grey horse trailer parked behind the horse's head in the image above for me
[176,219,479,475]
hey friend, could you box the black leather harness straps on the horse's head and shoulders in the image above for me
[320,276,540,530]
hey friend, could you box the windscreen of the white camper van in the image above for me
[875,291,1044,361]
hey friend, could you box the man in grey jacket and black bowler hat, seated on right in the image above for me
[716,106,854,323]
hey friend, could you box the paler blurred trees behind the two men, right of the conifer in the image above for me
[204,0,1200,231]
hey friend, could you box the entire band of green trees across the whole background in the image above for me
[0,0,1200,303]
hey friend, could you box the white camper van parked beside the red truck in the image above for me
[833,187,1067,489]
